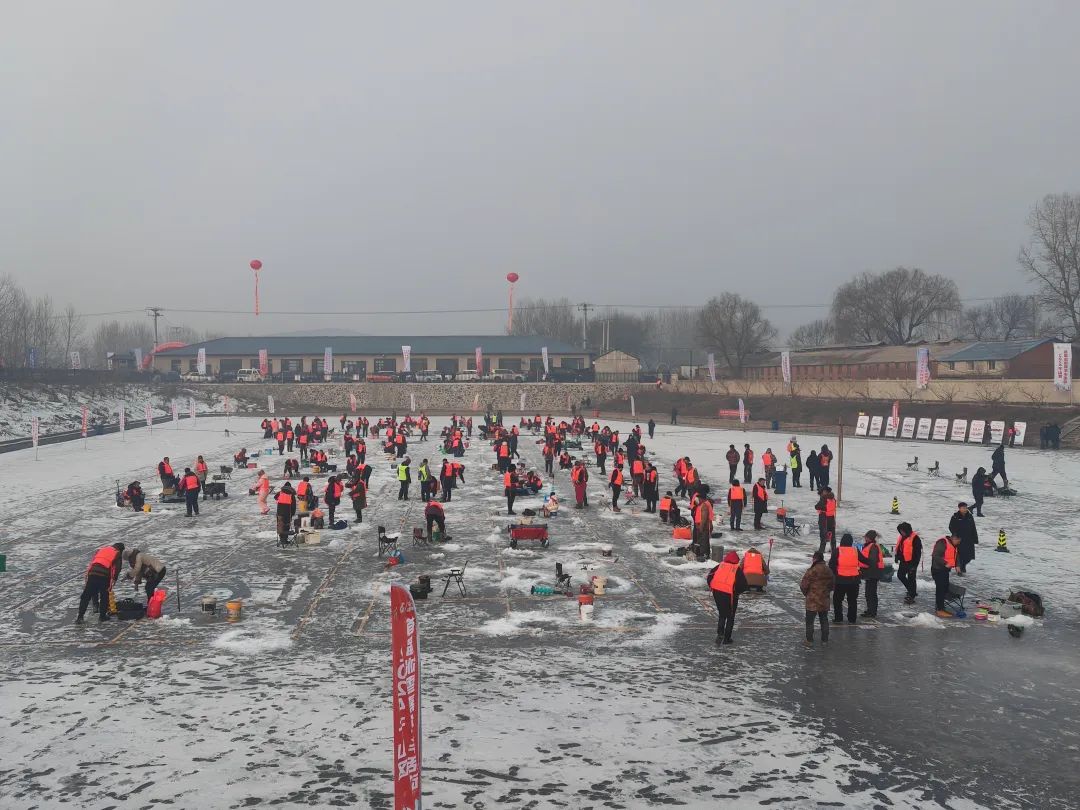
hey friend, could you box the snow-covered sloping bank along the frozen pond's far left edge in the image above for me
[0,383,247,441]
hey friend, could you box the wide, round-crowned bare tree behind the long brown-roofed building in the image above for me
[832,267,960,346]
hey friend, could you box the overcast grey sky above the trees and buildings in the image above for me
[0,0,1080,334]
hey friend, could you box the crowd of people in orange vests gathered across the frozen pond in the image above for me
[78,413,1009,644]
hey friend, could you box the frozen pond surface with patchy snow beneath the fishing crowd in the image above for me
[0,419,1080,808]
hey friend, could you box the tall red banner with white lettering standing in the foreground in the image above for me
[390,583,422,810]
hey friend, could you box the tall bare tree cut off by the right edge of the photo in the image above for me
[1020,194,1080,338]
